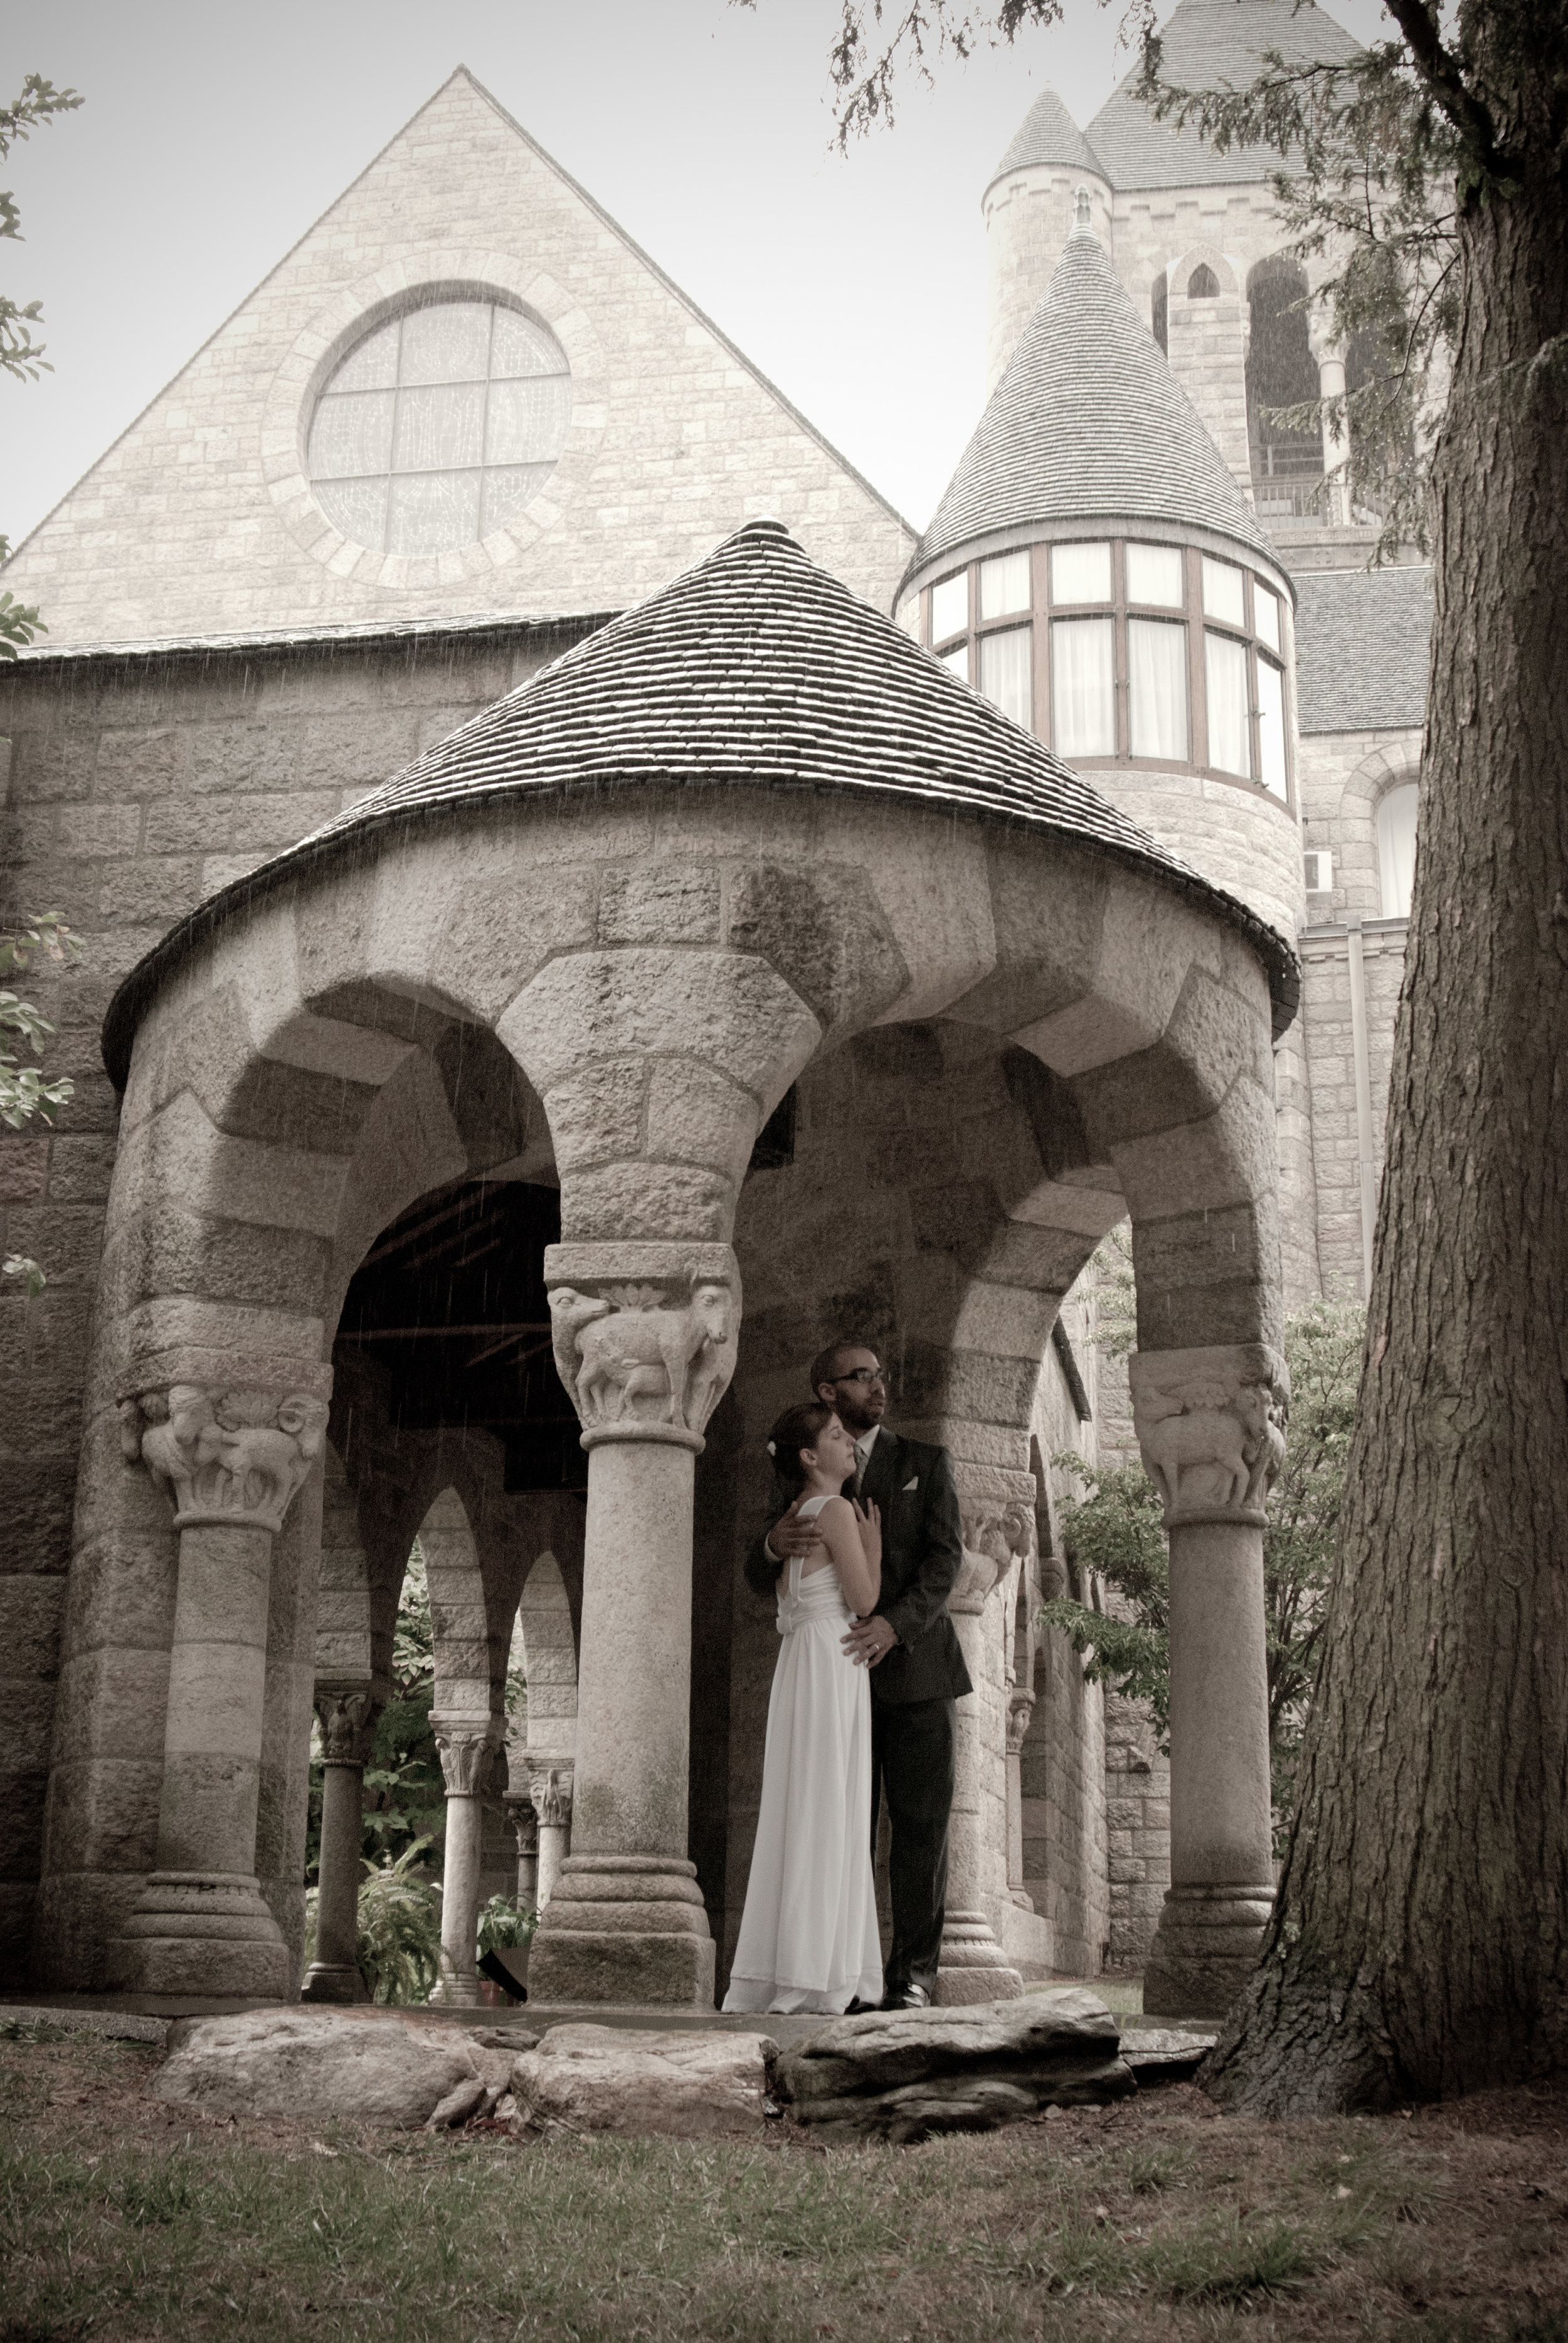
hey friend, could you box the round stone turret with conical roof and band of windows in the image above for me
[898,201,1303,935]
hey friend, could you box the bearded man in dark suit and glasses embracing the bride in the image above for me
[745,1342,973,2011]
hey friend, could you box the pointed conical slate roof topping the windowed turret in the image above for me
[900,227,1279,593]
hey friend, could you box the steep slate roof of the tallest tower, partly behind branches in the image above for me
[1083,0,1362,190]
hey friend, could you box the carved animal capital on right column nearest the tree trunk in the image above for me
[1127,1342,1291,1530]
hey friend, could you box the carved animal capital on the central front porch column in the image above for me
[544,1242,741,1450]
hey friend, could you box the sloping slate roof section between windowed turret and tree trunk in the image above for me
[1296,567,1432,733]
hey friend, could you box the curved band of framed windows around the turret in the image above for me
[923,539,1289,804]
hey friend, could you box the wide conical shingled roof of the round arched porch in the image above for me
[103,520,1298,1085]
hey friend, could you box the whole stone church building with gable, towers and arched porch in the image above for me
[0,0,1428,2006]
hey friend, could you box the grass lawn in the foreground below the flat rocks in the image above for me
[0,2027,1568,2343]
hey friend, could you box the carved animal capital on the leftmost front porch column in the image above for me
[120,1383,326,1530]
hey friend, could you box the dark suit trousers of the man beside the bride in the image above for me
[872,1696,958,1999]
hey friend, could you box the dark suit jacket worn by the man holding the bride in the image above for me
[745,1425,975,1703]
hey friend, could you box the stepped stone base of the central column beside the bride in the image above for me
[527,1856,712,2011]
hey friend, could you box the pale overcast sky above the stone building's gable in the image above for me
[0,0,1380,546]
